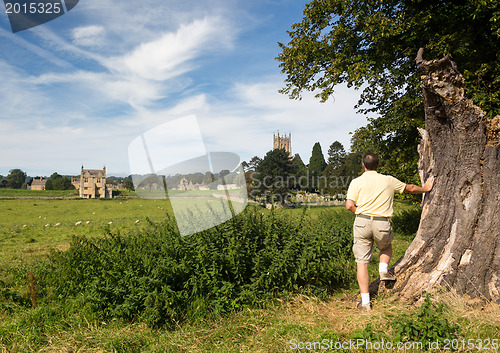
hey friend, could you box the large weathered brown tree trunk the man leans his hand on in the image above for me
[376,50,500,303]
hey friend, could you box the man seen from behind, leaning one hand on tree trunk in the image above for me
[346,153,434,311]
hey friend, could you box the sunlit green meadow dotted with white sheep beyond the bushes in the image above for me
[0,197,171,264]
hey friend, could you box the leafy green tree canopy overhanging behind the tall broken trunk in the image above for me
[277,0,500,181]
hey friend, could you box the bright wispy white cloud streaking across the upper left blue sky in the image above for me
[22,17,234,110]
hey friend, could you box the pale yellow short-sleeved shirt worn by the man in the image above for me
[347,170,406,217]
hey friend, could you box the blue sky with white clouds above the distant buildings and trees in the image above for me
[0,0,366,176]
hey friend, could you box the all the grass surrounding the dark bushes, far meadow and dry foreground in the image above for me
[0,199,500,353]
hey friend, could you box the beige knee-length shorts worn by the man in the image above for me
[352,217,394,264]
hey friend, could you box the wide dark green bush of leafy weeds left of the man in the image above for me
[39,209,355,327]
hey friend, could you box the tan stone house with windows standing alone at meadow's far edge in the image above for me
[71,165,113,199]
